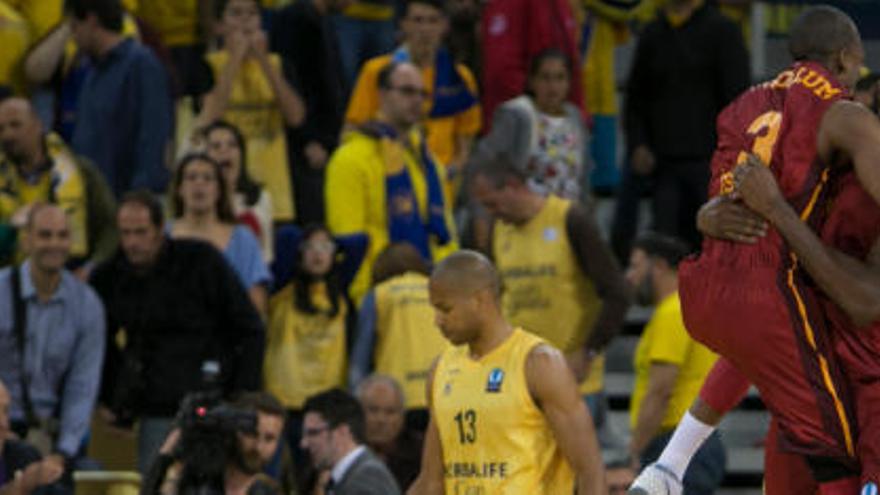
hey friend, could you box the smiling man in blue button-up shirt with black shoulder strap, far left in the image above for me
[0,203,105,465]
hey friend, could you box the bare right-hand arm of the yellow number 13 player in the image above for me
[526,345,605,495]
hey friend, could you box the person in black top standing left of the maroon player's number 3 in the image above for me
[612,0,751,261]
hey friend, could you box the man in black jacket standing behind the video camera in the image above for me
[91,191,265,472]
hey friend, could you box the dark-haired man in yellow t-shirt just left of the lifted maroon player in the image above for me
[627,234,726,494]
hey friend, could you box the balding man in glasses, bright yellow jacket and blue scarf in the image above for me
[324,62,457,303]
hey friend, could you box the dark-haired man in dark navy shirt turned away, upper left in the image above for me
[65,0,173,198]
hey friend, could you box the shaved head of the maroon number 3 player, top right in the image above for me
[788,5,861,62]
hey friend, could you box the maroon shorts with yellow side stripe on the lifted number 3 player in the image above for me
[679,259,857,462]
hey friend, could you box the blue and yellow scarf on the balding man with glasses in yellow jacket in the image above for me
[361,122,450,261]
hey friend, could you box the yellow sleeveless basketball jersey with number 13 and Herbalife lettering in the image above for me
[431,328,574,495]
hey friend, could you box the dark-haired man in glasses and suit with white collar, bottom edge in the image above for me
[302,389,400,495]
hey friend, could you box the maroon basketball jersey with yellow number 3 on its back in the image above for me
[702,62,848,269]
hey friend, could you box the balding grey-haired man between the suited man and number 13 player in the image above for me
[356,374,424,489]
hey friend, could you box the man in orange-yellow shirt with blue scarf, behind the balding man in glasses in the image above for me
[345,0,482,200]
